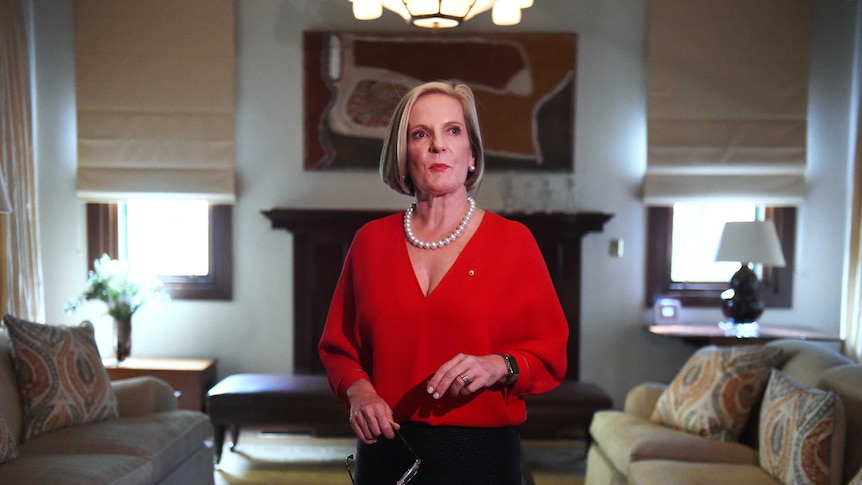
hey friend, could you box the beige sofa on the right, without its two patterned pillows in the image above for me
[586,340,862,485]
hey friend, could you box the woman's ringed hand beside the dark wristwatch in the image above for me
[428,354,507,399]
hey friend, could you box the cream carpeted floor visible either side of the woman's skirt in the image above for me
[215,429,585,485]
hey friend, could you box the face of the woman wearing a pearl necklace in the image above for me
[407,93,475,197]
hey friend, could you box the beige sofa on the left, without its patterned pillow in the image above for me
[0,329,214,485]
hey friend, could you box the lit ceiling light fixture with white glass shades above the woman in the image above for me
[350,0,533,30]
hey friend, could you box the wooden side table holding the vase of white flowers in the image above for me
[102,357,218,411]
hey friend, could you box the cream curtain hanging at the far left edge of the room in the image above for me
[0,0,44,321]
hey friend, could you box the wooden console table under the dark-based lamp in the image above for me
[647,324,842,346]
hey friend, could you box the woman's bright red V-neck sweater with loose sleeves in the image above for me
[319,212,568,427]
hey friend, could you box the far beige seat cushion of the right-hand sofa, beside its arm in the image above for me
[590,411,758,473]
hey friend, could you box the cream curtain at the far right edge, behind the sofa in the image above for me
[842,2,862,362]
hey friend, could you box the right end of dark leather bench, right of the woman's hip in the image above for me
[521,380,614,446]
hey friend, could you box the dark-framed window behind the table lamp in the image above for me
[645,203,796,308]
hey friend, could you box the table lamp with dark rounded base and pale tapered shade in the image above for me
[715,220,785,334]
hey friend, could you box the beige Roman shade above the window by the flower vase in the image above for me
[75,0,235,204]
